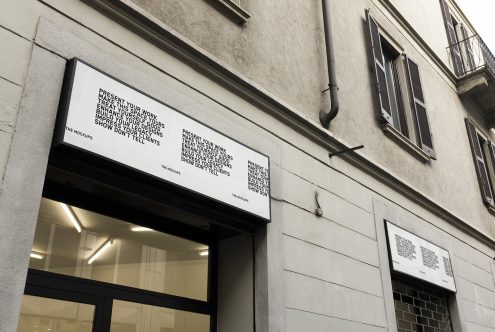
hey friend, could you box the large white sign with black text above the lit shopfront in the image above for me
[56,59,270,220]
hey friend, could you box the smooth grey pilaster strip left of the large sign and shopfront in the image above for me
[0,47,65,331]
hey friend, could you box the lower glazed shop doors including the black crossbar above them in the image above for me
[17,270,210,332]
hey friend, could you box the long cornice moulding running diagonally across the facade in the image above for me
[84,0,495,250]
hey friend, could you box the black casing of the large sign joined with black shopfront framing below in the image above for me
[19,54,271,332]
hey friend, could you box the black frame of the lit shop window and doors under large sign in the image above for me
[24,179,218,332]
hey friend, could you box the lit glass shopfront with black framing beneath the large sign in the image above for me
[17,193,216,332]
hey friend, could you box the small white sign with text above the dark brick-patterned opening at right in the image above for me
[386,221,456,292]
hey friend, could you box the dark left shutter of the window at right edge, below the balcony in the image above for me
[465,119,493,205]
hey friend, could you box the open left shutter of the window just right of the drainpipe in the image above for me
[366,11,392,124]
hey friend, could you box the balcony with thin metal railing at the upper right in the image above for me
[449,35,495,127]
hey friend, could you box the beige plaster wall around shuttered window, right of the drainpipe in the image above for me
[331,1,495,236]
